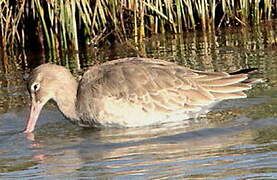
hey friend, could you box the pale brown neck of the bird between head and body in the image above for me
[54,78,79,121]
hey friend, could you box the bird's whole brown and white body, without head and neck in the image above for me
[74,58,251,126]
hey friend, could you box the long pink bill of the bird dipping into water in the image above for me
[24,101,44,133]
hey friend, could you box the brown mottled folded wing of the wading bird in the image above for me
[79,58,250,116]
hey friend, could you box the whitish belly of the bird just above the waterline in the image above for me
[88,97,213,127]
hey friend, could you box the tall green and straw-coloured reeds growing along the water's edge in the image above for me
[0,0,277,56]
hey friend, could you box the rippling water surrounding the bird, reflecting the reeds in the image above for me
[0,23,277,180]
